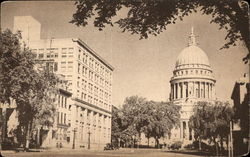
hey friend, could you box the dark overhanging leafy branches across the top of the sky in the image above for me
[70,0,250,62]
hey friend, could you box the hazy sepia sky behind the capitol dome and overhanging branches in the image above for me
[1,1,248,107]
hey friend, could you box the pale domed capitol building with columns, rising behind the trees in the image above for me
[169,28,216,143]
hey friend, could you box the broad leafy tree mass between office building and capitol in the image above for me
[112,96,180,147]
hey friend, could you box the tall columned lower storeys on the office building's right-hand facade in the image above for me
[75,106,111,149]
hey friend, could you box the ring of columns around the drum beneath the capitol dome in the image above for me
[171,81,215,100]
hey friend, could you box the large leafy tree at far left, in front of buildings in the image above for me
[0,30,57,149]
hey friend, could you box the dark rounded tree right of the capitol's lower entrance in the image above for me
[189,101,234,155]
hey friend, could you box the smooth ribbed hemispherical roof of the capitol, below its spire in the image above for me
[175,45,210,67]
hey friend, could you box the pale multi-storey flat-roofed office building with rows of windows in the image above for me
[14,17,114,149]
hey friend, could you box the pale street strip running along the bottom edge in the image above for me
[3,149,207,157]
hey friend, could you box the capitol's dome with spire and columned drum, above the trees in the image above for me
[170,28,216,101]
